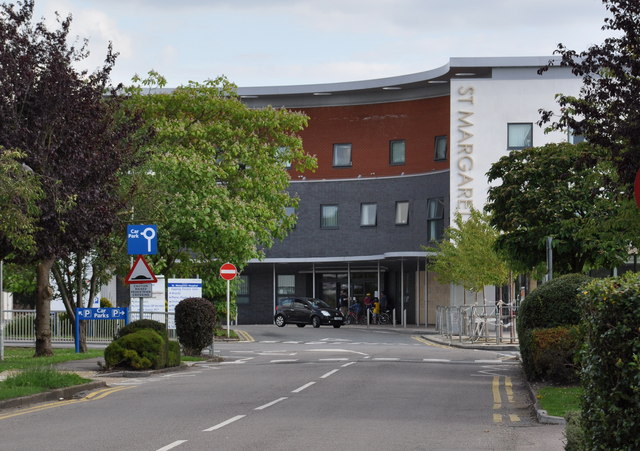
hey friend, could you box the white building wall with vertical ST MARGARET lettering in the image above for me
[449,67,581,224]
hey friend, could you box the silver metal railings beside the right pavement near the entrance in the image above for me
[436,302,518,343]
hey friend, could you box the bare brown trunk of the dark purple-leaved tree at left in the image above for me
[35,257,55,357]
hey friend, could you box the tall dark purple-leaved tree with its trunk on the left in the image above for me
[0,0,145,356]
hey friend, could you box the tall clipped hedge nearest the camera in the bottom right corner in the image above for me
[580,273,640,450]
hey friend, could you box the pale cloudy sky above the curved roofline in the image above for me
[35,0,607,87]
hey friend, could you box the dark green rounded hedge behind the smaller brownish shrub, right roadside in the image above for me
[517,274,591,380]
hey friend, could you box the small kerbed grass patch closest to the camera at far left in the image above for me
[0,368,91,400]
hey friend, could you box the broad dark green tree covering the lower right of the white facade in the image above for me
[485,143,639,274]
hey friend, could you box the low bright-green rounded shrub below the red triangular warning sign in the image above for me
[104,329,167,370]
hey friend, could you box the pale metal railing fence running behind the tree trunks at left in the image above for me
[4,310,176,344]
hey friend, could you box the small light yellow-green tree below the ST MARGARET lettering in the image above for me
[425,209,509,299]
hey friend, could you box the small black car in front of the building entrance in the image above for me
[274,298,344,329]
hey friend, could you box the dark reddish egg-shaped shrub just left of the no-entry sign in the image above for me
[175,298,216,356]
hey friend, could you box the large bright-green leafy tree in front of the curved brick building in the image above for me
[124,72,315,297]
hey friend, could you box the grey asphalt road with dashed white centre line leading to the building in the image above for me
[0,326,562,451]
